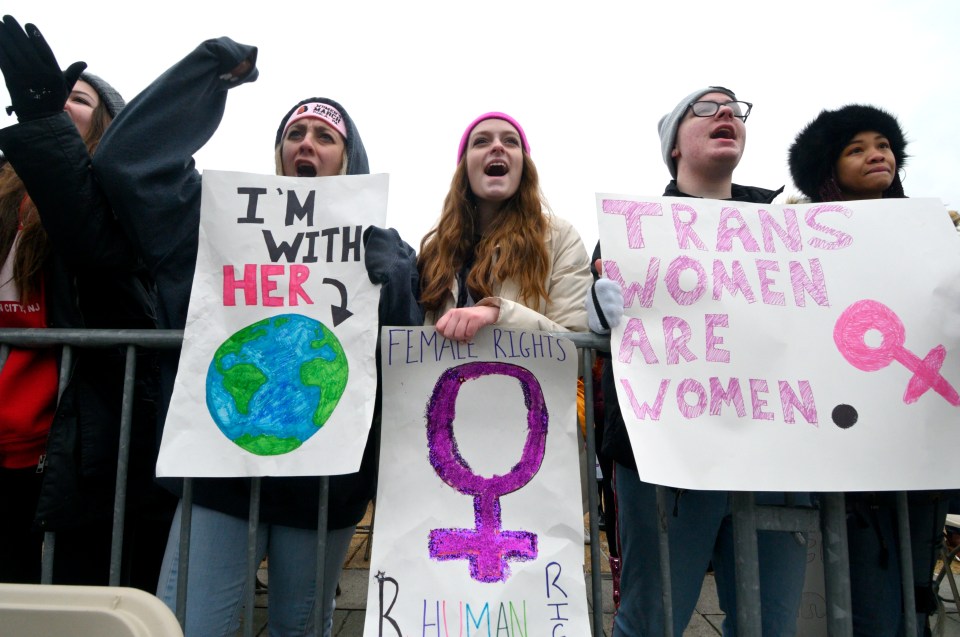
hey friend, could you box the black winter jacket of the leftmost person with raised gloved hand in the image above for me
[0,113,169,531]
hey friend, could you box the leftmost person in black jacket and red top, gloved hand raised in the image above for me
[0,16,174,590]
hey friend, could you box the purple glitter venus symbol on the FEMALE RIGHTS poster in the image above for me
[427,362,549,582]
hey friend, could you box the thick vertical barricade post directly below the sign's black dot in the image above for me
[820,493,853,637]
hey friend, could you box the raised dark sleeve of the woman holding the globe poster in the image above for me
[93,37,258,329]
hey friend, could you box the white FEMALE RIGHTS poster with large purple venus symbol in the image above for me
[364,327,590,637]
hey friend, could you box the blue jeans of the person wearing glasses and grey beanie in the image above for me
[614,463,807,637]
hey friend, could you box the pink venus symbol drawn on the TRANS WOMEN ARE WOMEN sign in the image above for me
[833,299,960,406]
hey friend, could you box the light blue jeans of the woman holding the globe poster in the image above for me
[157,502,356,637]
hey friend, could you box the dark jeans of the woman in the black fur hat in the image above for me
[847,491,949,637]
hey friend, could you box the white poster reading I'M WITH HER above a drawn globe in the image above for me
[157,171,387,476]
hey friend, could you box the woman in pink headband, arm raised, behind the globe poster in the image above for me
[94,38,422,637]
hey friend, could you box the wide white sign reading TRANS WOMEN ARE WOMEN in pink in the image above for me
[597,194,960,491]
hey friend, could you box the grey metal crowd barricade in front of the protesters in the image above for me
[0,329,928,637]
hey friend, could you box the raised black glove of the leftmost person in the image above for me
[0,15,87,122]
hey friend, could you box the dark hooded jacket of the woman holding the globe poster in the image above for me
[94,38,423,529]
